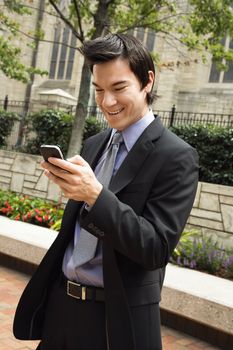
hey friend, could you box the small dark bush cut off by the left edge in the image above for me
[0,109,19,147]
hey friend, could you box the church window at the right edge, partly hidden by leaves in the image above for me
[209,37,233,84]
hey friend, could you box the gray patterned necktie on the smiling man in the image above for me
[73,132,123,267]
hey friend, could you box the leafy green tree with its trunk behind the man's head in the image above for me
[0,0,233,155]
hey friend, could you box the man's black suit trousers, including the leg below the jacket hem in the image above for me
[37,280,162,350]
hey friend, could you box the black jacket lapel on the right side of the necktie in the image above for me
[109,117,164,193]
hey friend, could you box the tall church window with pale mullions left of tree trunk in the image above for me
[49,24,77,80]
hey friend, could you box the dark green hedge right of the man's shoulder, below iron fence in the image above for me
[171,125,233,186]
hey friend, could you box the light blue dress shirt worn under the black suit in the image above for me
[62,110,154,287]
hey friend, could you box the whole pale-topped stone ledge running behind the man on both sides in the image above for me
[0,216,233,337]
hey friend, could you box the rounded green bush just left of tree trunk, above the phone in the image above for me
[25,109,73,154]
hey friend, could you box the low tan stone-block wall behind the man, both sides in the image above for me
[0,150,233,247]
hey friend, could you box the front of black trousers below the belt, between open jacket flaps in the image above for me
[38,280,107,350]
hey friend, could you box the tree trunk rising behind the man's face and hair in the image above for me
[67,0,114,157]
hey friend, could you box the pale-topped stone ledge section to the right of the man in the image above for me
[160,264,233,336]
